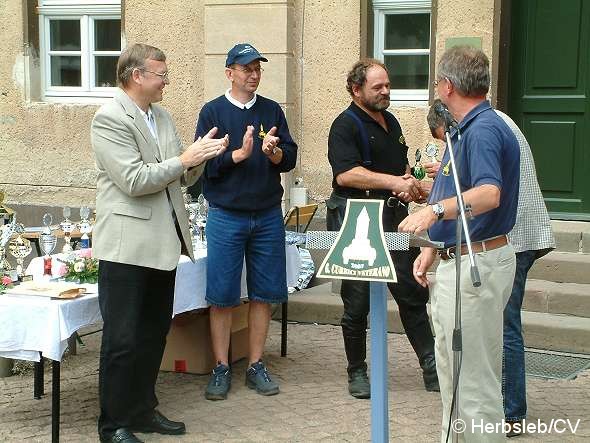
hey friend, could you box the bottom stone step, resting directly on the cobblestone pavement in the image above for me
[284,282,590,354]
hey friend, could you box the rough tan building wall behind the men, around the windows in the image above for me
[0,0,497,215]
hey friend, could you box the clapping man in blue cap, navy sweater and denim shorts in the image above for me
[195,43,297,400]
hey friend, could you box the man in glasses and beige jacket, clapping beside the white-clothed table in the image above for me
[91,44,227,442]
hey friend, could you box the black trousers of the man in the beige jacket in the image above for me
[98,260,176,436]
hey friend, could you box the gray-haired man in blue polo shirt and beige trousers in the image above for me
[399,46,520,442]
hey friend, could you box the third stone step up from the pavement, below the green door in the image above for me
[528,251,590,284]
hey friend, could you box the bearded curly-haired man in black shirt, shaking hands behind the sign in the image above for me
[326,59,439,398]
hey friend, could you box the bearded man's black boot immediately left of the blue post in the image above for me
[342,331,371,398]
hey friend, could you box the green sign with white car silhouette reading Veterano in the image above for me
[317,200,397,282]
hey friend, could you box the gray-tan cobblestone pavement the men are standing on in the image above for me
[0,322,590,442]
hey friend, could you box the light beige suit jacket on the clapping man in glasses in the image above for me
[91,89,204,270]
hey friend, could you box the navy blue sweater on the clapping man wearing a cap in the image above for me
[195,95,297,211]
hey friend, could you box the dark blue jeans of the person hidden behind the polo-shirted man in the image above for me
[502,251,537,421]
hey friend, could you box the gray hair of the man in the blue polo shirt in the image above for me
[437,46,490,97]
